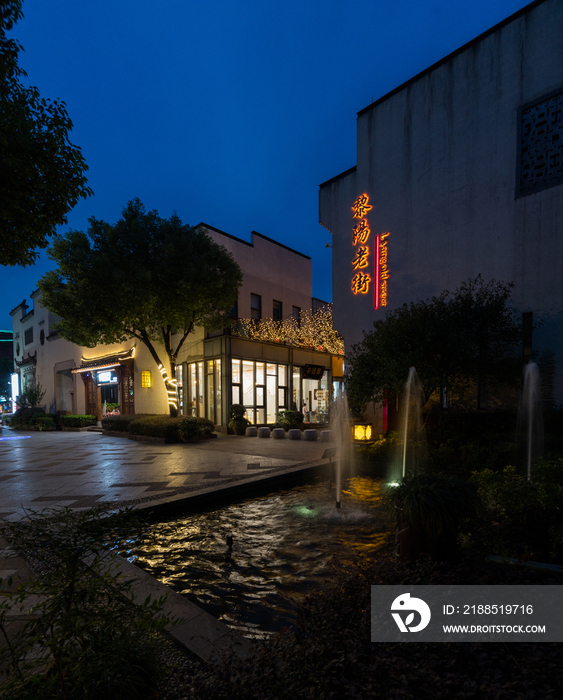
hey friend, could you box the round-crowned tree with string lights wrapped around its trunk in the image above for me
[38,199,242,416]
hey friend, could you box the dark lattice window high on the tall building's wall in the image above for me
[516,90,563,197]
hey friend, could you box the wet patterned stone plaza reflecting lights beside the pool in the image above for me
[0,428,331,520]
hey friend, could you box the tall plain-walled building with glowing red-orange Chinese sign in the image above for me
[320,0,563,418]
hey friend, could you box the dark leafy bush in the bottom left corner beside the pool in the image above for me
[0,507,169,700]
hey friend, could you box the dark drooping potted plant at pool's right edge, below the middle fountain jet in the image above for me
[386,474,480,560]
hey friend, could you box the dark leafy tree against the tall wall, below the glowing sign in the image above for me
[347,275,522,410]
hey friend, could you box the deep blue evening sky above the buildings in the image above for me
[0,0,528,329]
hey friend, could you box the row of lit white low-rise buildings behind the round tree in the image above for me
[11,224,343,431]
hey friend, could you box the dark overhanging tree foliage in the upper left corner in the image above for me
[0,0,92,267]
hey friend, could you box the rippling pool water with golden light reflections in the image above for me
[120,477,389,636]
